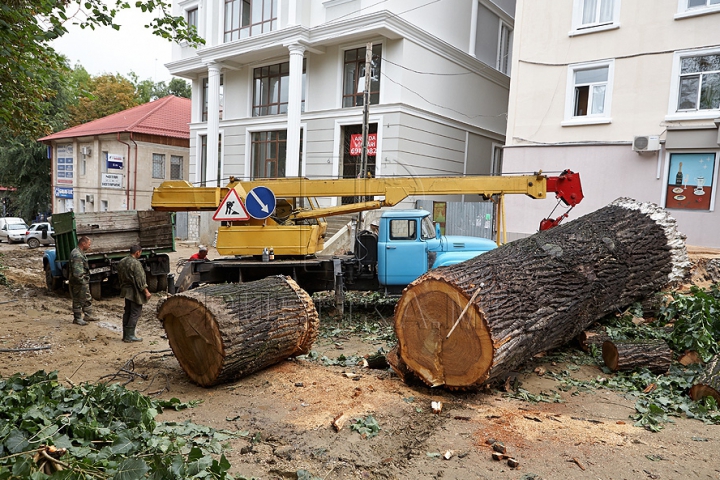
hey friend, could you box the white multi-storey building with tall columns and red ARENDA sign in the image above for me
[167,0,515,209]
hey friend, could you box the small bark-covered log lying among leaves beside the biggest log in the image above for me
[603,340,672,373]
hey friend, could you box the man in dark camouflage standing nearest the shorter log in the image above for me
[117,245,152,342]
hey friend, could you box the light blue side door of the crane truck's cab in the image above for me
[378,218,428,285]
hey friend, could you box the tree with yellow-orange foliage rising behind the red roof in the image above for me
[70,74,140,126]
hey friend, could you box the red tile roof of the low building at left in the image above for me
[39,95,191,142]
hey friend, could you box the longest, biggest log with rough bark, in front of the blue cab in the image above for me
[395,198,690,388]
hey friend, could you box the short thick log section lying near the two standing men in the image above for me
[157,276,319,387]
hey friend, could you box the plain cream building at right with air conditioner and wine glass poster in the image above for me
[503,0,720,247]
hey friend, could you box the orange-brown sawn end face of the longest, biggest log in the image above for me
[395,279,493,387]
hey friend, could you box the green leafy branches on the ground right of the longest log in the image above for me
[506,284,720,432]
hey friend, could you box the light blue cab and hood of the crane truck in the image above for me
[377,210,497,286]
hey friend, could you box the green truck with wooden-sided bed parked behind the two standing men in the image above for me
[43,210,175,300]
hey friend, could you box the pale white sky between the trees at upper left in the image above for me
[52,8,172,83]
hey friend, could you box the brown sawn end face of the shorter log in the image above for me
[158,298,225,386]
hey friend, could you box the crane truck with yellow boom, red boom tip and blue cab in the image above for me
[152,170,583,293]
